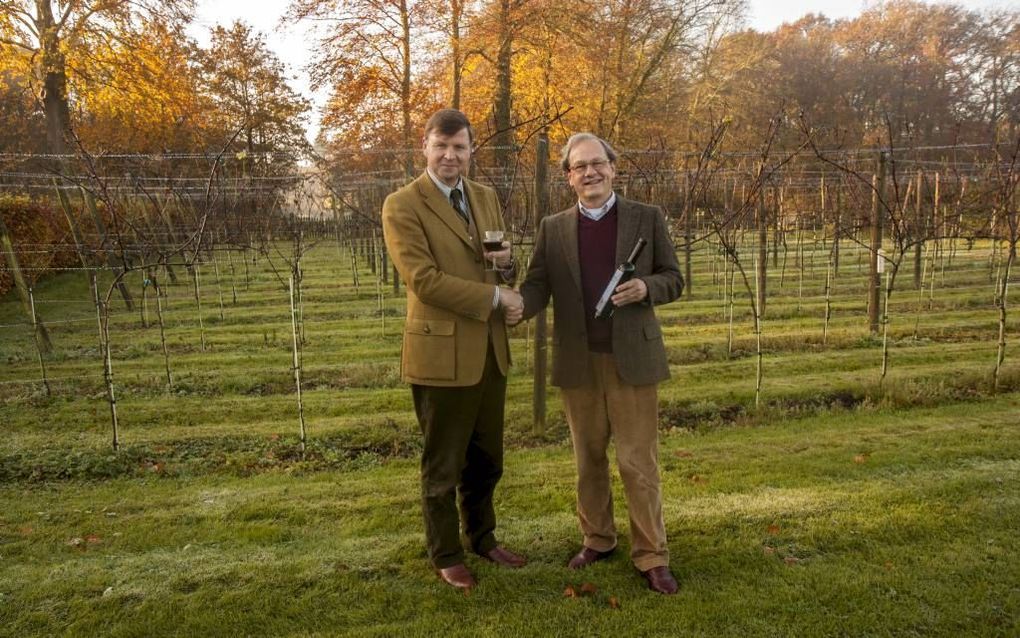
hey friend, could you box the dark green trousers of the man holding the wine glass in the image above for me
[411,346,507,569]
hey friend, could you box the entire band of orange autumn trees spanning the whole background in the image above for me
[0,0,1020,168]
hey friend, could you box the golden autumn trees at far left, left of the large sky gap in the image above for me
[0,0,310,161]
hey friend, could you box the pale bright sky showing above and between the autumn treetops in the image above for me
[189,0,1020,139]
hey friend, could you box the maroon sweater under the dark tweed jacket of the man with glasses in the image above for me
[577,204,618,352]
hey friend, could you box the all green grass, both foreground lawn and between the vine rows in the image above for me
[0,233,1020,636]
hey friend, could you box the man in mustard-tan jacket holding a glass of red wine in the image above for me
[383,109,524,588]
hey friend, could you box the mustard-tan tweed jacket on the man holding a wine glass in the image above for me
[383,173,510,386]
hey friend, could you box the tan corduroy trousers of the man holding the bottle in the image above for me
[561,352,669,572]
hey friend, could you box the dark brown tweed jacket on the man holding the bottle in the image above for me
[520,196,683,388]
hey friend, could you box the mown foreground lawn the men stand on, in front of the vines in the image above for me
[0,394,1020,636]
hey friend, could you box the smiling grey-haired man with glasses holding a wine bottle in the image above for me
[520,133,683,594]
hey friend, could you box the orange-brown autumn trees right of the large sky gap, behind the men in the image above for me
[303,0,1020,169]
